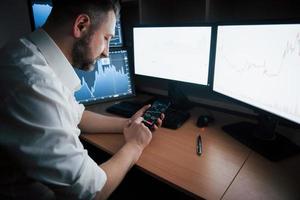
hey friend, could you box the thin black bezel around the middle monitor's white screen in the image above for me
[132,23,214,89]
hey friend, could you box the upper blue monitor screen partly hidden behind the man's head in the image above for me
[31,0,123,47]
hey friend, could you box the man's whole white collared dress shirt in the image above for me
[0,29,107,199]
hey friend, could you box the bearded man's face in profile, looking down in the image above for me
[72,11,116,71]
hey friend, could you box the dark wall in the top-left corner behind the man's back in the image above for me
[0,0,31,47]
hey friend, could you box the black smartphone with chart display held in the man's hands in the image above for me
[143,99,171,130]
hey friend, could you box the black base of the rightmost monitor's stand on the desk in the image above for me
[222,116,300,161]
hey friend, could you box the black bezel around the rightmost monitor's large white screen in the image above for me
[211,19,300,128]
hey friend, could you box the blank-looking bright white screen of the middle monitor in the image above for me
[133,26,211,85]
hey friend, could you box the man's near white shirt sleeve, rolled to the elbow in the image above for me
[0,79,107,199]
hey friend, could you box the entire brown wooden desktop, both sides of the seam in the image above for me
[81,99,300,199]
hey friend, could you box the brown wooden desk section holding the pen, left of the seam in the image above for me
[81,101,250,199]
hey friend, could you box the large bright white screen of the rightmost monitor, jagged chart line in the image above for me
[213,24,300,124]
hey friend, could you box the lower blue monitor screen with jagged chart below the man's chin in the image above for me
[75,50,134,104]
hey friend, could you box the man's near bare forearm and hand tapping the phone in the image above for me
[96,105,164,199]
